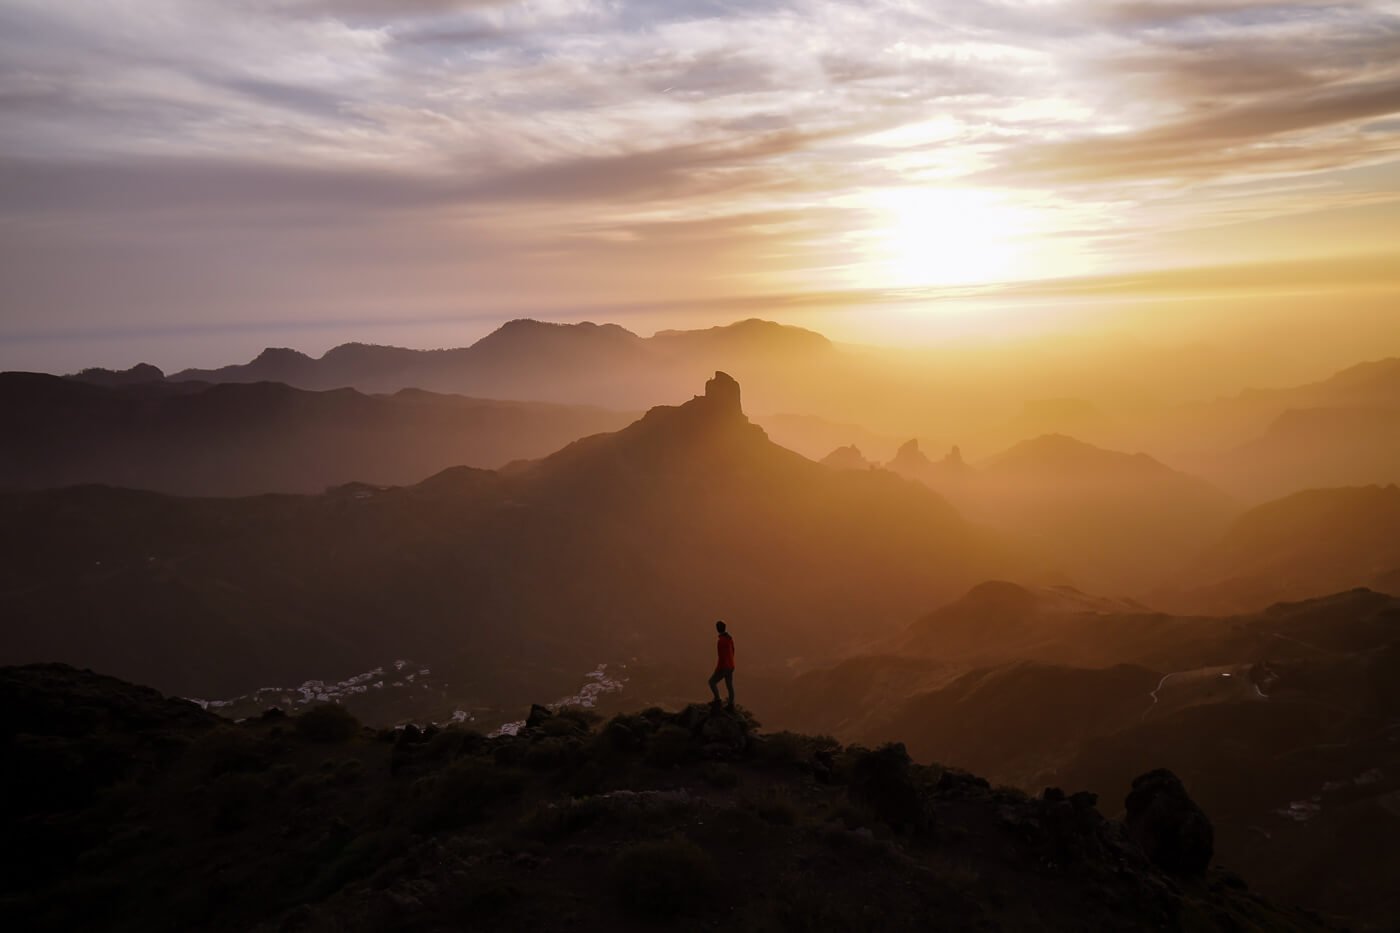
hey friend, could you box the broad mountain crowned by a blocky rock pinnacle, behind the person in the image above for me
[0,374,1005,696]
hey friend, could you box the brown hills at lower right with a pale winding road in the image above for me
[783,583,1400,926]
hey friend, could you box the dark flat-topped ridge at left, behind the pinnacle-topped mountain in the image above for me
[0,373,634,496]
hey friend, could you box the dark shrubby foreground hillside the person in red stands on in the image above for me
[0,665,1324,933]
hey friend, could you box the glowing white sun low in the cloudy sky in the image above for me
[865,188,1036,287]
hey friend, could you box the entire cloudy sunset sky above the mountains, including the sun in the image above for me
[0,0,1400,371]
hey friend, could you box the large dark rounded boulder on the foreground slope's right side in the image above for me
[1124,768,1215,877]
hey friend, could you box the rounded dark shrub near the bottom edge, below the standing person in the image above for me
[612,838,720,920]
